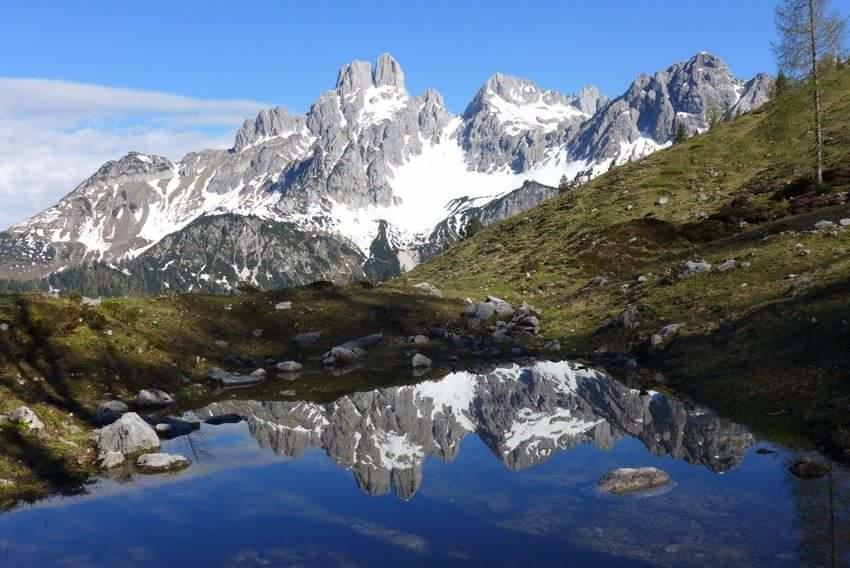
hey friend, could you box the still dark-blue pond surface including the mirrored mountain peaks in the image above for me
[0,362,848,567]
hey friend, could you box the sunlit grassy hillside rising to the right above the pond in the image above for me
[395,63,850,446]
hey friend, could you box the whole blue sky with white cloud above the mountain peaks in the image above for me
[0,0,850,229]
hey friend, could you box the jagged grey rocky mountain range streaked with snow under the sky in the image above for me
[0,54,771,290]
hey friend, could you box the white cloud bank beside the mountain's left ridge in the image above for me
[0,78,271,228]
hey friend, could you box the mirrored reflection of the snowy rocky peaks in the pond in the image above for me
[190,361,753,499]
